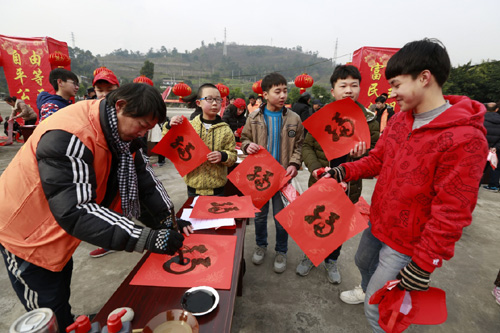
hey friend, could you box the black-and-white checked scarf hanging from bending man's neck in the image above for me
[106,105,141,218]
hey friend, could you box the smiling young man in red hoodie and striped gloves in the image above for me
[329,39,488,332]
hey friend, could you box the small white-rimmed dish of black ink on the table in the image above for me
[181,286,219,316]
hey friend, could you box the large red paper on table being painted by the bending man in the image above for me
[130,234,236,290]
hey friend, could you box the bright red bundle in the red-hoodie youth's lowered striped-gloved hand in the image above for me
[370,280,448,333]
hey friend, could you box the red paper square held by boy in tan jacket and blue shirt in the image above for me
[227,147,292,209]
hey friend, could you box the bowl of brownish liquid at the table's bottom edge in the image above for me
[142,309,200,333]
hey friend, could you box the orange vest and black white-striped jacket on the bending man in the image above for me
[0,100,172,272]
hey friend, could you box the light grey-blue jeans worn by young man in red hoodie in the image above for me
[365,243,411,333]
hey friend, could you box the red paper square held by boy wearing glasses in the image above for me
[151,116,211,177]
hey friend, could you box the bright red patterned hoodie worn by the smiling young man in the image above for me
[343,96,488,272]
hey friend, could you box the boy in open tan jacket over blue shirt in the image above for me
[241,73,304,273]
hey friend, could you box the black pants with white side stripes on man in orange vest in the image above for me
[0,244,74,332]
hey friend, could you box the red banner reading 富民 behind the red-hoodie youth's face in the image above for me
[352,46,399,111]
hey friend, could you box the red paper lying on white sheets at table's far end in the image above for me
[190,195,255,219]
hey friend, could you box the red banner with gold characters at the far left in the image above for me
[0,35,71,113]
